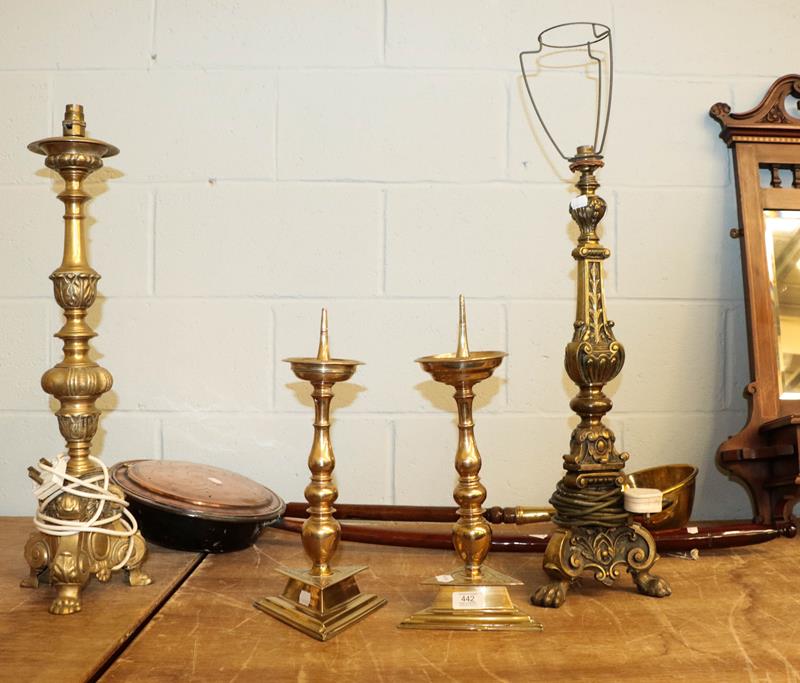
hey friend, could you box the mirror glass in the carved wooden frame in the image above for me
[764,209,800,400]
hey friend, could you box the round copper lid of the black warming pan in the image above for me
[111,460,286,522]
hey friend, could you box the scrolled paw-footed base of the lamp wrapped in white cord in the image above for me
[20,522,152,614]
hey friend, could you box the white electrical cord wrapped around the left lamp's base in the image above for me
[33,453,139,571]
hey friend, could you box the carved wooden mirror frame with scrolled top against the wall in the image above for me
[710,74,800,525]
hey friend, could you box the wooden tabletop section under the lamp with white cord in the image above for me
[0,517,201,683]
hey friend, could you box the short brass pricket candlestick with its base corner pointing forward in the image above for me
[255,308,386,640]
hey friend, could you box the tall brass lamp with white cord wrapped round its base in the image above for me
[22,104,150,614]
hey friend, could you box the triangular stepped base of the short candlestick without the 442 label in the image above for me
[253,566,386,641]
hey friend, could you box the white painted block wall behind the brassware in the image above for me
[0,0,800,518]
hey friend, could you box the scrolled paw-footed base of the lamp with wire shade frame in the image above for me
[531,522,672,607]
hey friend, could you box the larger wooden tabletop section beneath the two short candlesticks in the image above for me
[102,529,800,683]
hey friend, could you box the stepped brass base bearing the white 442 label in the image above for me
[399,567,542,631]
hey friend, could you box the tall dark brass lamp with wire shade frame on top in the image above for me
[520,22,671,607]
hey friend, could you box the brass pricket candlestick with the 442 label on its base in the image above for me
[400,296,542,631]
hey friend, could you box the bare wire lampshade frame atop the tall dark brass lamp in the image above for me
[519,21,614,161]
